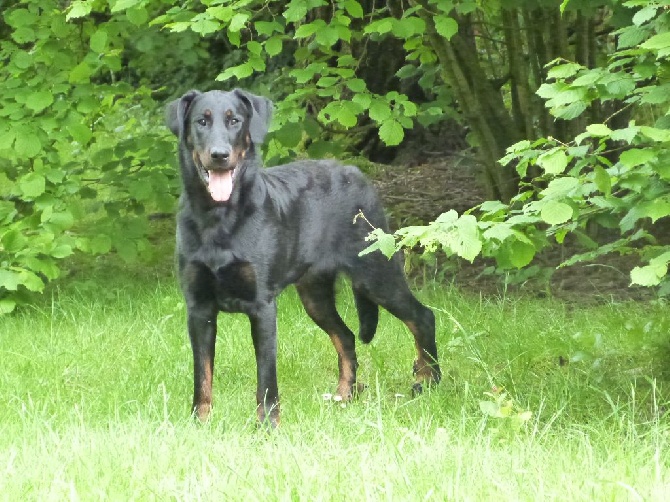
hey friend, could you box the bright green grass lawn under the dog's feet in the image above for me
[0,259,670,501]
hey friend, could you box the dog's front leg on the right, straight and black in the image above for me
[249,300,279,428]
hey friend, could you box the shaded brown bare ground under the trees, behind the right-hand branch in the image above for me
[375,156,652,301]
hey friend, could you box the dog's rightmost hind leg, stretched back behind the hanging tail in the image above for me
[351,255,441,393]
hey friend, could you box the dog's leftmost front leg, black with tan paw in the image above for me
[188,313,216,422]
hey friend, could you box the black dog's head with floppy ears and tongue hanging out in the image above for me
[166,89,272,202]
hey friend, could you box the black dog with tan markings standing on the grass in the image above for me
[167,90,440,427]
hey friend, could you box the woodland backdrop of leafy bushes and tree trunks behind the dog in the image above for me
[0,0,670,313]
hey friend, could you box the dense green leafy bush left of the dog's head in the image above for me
[0,0,176,313]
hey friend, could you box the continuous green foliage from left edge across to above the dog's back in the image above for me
[0,0,468,312]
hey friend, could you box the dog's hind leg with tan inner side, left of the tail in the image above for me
[296,274,360,400]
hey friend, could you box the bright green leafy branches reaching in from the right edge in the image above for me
[369,0,670,294]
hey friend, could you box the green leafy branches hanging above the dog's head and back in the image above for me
[151,0,456,162]
